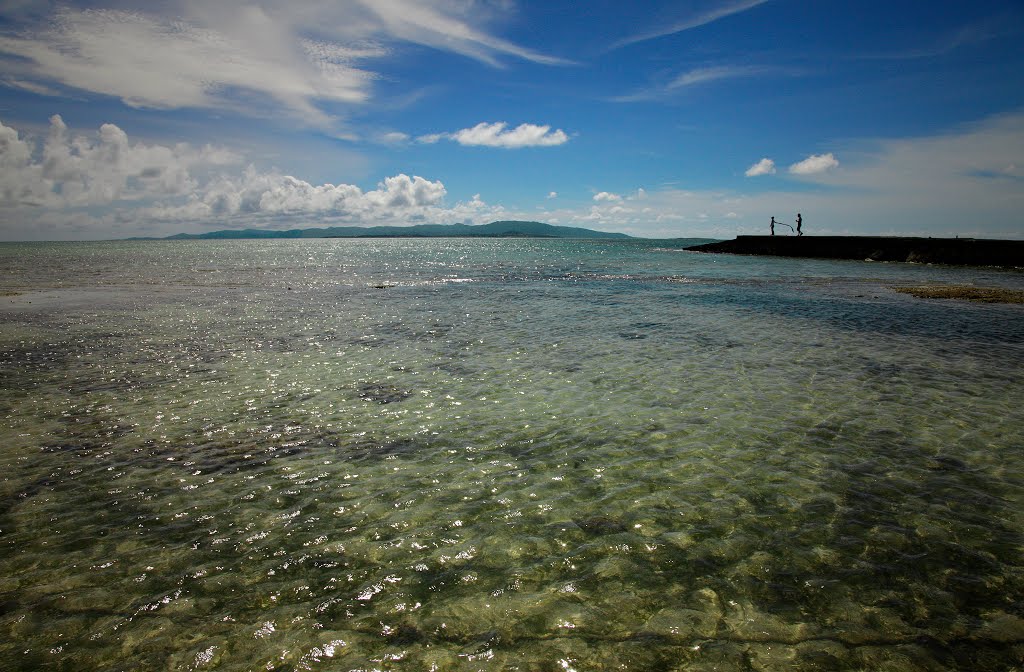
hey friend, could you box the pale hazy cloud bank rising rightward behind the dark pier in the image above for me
[549,114,1024,239]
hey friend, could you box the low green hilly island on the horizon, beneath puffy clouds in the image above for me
[157,221,631,241]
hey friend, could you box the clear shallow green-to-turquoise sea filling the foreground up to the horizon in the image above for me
[0,240,1024,671]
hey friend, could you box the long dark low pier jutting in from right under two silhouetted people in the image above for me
[686,236,1024,266]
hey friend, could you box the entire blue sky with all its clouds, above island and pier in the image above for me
[0,0,1024,241]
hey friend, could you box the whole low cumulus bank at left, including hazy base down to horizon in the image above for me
[0,116,516,240]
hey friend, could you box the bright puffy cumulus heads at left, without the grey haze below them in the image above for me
[0,116,445,217]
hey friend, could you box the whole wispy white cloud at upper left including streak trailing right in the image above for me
[0,0,562,128]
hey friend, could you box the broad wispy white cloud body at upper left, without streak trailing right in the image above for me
[0,8,371,126]
